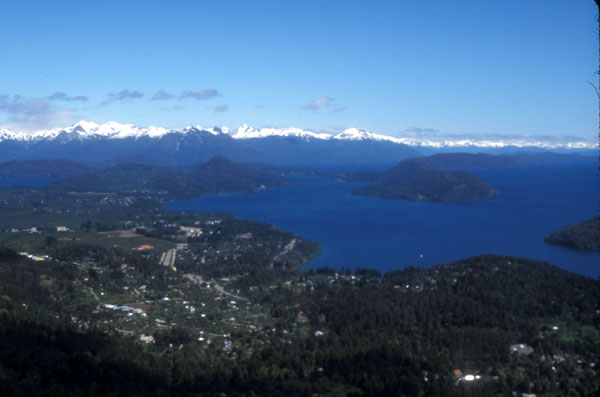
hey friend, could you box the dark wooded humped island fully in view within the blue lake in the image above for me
[353,160,498,202]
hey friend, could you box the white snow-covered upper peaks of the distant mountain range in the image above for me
[0,121,597,149]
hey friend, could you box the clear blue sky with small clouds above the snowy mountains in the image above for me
[0,0,598,141]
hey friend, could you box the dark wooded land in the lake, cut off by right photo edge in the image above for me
[544,216,600,251]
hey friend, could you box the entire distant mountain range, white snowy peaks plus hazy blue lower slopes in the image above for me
[0,121,595,166]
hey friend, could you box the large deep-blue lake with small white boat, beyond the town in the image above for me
[166,165,600,277]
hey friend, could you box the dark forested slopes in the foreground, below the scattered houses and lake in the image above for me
[0,244,600,396]
